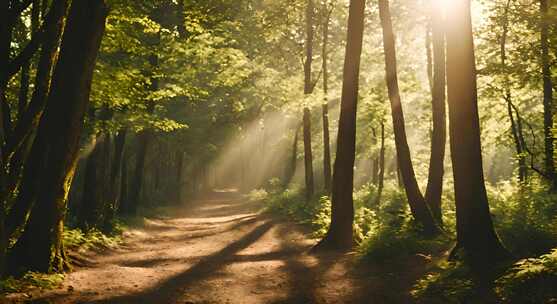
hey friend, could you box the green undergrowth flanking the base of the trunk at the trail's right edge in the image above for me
[252,184,448,259]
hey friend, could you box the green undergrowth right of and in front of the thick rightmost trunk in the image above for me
[406,180,557,304]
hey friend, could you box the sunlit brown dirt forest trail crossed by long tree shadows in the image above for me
[15,193,426,304]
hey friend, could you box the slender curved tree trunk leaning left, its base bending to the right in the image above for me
[379,0,439,234]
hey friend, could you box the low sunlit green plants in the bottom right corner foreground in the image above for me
[411,248,557,304]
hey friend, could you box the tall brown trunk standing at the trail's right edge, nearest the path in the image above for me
[315,0,365,250]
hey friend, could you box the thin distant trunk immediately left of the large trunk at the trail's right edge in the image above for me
[321,4,332,193]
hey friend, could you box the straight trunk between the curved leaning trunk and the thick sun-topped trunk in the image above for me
[425,2,447,224]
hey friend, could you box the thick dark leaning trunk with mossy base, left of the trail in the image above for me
[10,0,107,272]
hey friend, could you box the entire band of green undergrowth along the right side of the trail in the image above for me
[254,179,557,304]
